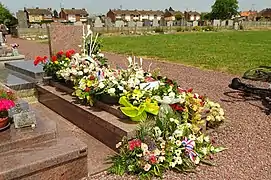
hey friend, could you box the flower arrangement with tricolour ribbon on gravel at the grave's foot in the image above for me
[109,104,225,179]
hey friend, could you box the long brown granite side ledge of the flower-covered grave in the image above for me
[37,85,137,150]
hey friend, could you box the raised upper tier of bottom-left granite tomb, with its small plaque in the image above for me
[0,117,56,154]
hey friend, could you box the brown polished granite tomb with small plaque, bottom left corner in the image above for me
[0,109,88,180]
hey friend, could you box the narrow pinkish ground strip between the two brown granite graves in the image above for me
[30,103,116,175]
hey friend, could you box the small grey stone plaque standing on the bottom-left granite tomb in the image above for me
[13,111,37,129]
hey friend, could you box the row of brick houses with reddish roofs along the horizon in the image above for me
[21,7,271,23]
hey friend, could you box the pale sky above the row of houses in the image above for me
[0,0,271,14]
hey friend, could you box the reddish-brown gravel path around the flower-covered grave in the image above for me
[9,35,271,180]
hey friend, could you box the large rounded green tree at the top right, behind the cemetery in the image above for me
[211,0,239,20]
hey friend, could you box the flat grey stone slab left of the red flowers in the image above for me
[5,60,44,81]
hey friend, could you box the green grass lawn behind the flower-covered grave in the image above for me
[102,31,271,74]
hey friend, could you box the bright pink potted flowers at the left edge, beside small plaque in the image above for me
[0,99,15,130]
